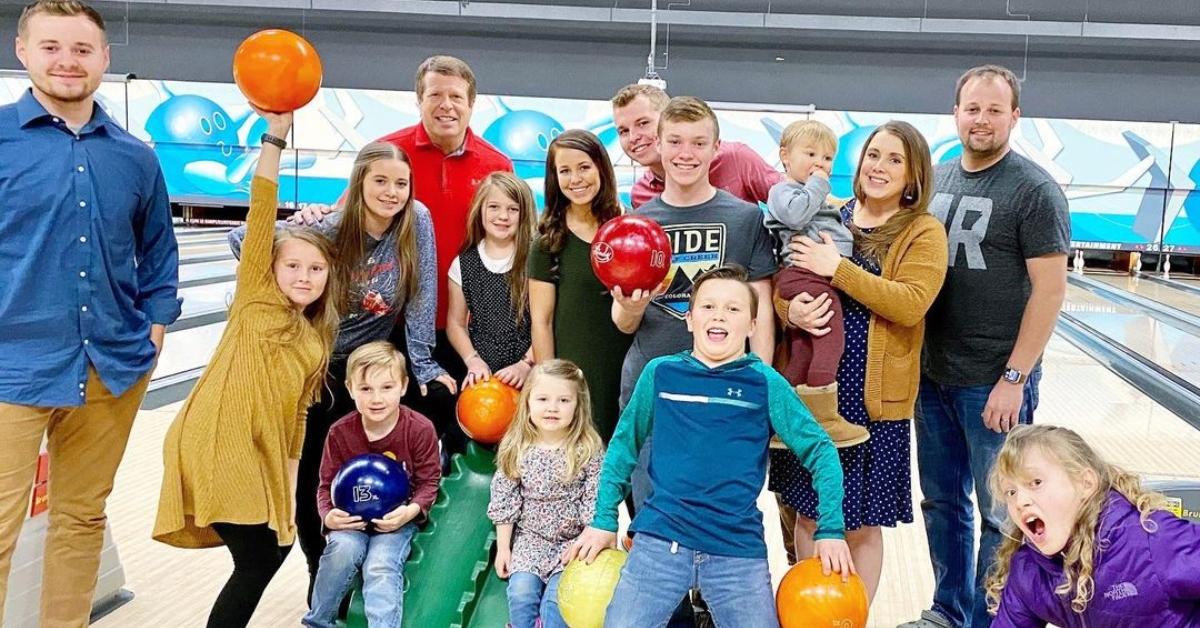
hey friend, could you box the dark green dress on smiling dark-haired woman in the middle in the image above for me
[529,231,634,444]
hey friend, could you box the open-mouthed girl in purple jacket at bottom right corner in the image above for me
[986,425,1200,628]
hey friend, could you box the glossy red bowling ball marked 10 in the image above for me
[592,214,671,297]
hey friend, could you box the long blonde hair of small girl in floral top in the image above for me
[496,359,602,484]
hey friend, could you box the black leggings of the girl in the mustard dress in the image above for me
[208,524,292,628]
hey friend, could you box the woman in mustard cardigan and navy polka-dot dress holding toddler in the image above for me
[770,120,947,599]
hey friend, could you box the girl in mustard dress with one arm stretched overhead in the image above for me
[154,109,341,628]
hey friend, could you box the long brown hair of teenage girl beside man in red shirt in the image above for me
[334,142,420,309]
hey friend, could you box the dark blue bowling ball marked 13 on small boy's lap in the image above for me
[331,454,408,521]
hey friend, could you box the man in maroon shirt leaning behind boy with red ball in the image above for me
[612,84,784,208]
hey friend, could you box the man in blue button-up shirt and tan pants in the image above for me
[0,0,180,626]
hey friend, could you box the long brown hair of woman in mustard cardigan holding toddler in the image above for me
[851,120,934,262]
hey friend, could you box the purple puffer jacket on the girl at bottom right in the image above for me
[991,491,1200,628]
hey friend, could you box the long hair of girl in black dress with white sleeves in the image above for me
[458,172,538,323]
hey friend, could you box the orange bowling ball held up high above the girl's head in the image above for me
[233,29,322,113]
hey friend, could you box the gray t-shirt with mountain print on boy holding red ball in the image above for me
[620,190,778,407]
